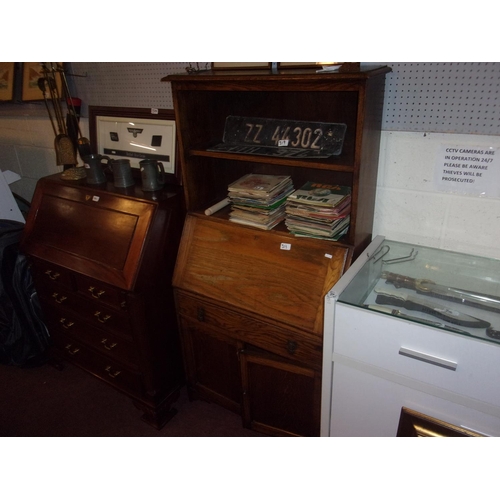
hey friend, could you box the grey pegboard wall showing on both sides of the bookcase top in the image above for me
[70,62,500,135]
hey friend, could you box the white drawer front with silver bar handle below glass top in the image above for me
[333,304,500,407]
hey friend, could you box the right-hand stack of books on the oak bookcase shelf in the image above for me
[285,182,351,241]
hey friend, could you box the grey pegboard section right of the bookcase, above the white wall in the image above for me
[382,62,500,135]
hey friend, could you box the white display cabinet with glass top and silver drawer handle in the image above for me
[321,236,500,436]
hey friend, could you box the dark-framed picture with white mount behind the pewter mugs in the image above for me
[89,106,180,179]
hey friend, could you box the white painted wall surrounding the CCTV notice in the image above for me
[373,131,500,259]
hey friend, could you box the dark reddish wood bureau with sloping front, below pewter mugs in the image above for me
[21,174,184,428]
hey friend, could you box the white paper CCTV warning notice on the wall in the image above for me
[435,144,500,197]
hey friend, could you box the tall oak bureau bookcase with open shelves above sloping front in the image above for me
[163,67,390,436]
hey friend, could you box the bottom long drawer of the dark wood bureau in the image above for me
[54,332,143,396]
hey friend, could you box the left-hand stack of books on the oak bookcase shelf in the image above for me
[228,174,293,229]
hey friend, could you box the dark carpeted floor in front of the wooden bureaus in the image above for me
[0,364,262,437]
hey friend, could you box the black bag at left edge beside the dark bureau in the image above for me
[0,219,52,367]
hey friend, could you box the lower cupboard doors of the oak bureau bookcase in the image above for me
[181,321,321,436]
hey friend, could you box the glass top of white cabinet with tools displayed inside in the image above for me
[338,239,500,343]
